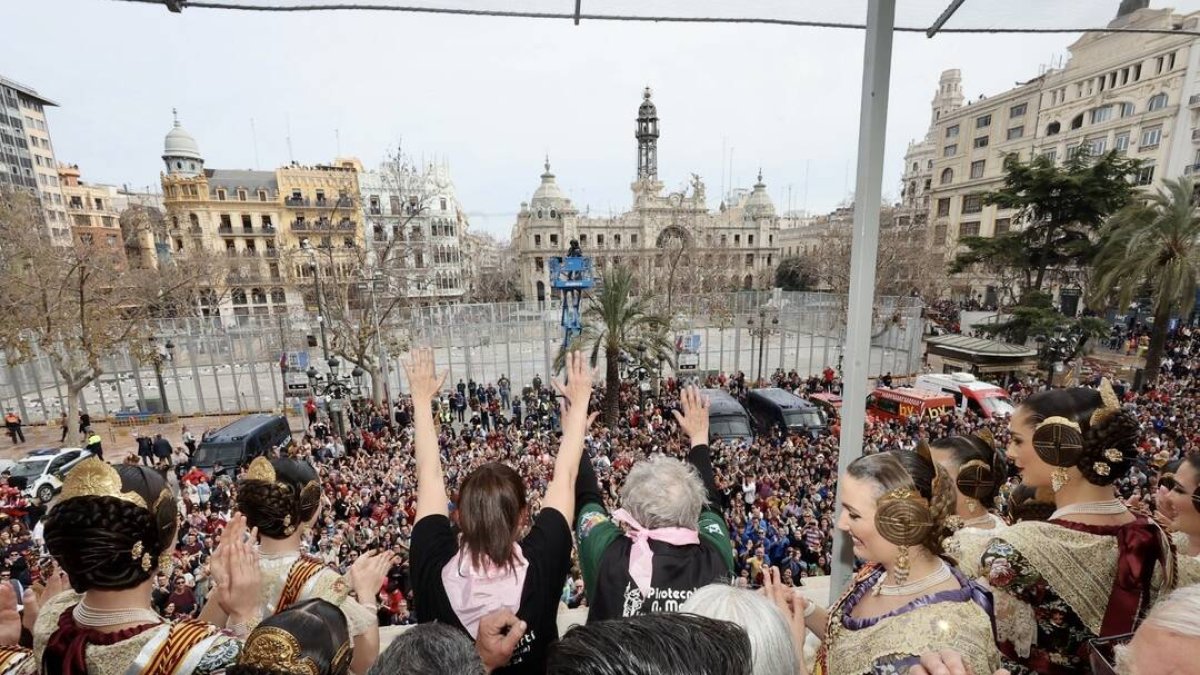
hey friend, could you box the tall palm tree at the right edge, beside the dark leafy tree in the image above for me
[1092,178,1200,386]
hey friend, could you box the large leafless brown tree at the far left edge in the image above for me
[0,190,205,443]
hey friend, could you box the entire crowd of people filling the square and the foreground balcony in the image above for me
[0,317,1200,675]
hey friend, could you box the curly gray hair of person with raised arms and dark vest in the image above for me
[620,455,706,530]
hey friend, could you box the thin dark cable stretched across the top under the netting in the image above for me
[105,0,1200,37]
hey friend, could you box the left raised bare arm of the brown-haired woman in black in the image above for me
[402,348,450,521]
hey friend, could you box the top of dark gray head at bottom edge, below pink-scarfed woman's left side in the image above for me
[367,623,484,675]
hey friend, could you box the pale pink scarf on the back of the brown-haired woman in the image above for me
[442,544,529,639]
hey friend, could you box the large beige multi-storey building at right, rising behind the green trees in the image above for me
[898,0,1200,300]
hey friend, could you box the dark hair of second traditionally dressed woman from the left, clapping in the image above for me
[238,458,320,539]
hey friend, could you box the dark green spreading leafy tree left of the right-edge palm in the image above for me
[949,151,1140,298]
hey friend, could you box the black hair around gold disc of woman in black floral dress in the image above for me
[1020,387,1140,485]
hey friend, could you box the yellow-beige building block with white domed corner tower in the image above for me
[161,112,362,322]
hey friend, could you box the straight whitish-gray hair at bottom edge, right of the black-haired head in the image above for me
[679,584,799,675]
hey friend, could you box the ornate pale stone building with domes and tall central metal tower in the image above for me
[512,89,780,300]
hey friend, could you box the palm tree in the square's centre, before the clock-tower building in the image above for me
[556,267,674,429]
